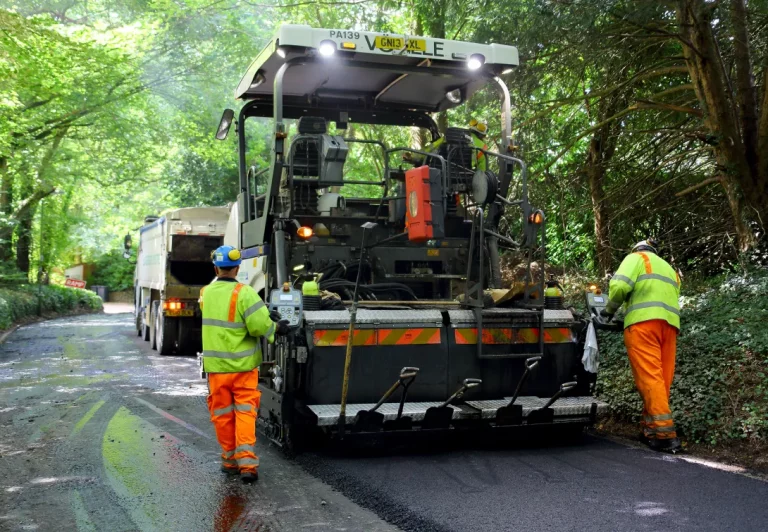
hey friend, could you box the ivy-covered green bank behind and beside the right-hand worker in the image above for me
[597,270,768,445]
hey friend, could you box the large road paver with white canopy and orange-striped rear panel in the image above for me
[216,25,607,448]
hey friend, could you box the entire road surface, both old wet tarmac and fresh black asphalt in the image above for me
[0,314,768,532]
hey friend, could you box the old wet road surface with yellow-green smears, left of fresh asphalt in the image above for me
[0,314,395,532]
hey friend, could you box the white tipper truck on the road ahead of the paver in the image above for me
[134,207,229,355]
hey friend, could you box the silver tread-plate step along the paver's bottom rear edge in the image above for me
[308,396,608,428]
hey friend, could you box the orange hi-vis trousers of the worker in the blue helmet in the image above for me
[208,368,261,473]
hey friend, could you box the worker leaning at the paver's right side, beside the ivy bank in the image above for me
[602,240,680,452]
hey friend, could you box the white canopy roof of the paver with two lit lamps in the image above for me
[235,25,518,112]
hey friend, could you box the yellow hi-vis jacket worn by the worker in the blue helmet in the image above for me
[200,279,276,373]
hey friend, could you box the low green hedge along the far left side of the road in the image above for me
[0,285,102,330]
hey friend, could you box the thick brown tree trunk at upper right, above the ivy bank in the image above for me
[677,0,768,250]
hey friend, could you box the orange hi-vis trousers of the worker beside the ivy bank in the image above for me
[624,320,677,439]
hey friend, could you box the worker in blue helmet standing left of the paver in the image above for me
[200,246,289,482]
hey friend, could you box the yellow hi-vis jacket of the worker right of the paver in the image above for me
[605,251,680,329]
